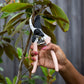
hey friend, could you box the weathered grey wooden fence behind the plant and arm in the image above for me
[0,0,84,84]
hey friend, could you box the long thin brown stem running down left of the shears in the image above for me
[15,30,32,84]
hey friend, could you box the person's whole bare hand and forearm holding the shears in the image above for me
[31,43,84,84]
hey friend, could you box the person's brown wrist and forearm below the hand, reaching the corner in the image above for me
[59,59,84,84]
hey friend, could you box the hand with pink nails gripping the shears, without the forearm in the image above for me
[31,43,67,70]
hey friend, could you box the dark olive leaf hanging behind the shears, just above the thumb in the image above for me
[41,25,56,44]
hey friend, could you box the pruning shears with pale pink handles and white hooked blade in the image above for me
[29,15,59,73]
